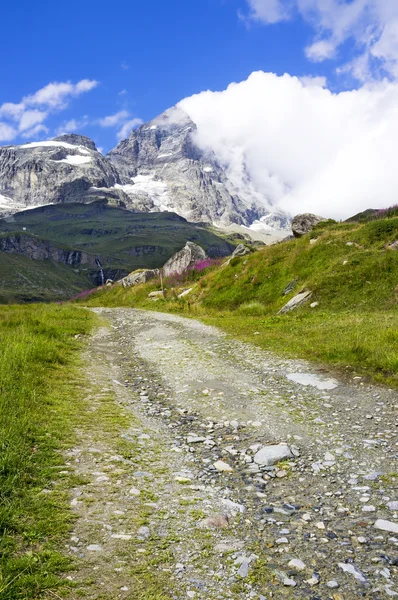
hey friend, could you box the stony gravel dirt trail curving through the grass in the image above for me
[64,309,398,600]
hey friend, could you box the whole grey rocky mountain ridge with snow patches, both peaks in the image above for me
[0,107,286,229]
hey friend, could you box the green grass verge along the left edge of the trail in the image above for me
[0,305,95,600]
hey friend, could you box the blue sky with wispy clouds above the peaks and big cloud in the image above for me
[0,0,398,150]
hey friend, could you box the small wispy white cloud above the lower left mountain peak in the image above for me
[0,79,98,141]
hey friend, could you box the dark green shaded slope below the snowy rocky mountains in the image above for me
[0,202,234,298]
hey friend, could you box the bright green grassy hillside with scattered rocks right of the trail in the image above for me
[84,217,398,383]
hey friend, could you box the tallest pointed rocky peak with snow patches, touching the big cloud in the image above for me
[107,107,266,225]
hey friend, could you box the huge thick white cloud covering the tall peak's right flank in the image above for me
[180,72,398,219]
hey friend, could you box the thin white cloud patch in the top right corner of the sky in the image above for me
[246,0,398,81]
